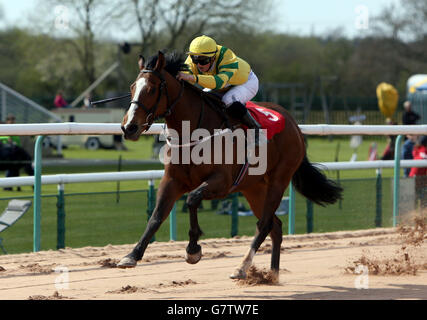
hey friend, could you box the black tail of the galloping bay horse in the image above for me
[292,156,343,206]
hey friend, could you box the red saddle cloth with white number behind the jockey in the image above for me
[246,101,285,140]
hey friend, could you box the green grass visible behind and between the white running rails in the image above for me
[0,137,402,253]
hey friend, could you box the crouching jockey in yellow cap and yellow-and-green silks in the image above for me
[177,35,261,144]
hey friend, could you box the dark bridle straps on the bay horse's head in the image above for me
[130,69,184,127]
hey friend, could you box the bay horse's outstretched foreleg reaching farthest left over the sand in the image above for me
[117,179,182,268]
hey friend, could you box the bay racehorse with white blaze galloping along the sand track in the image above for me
[117,51,342,279]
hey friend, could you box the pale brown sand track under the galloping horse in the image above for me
[0,229,427,300]
